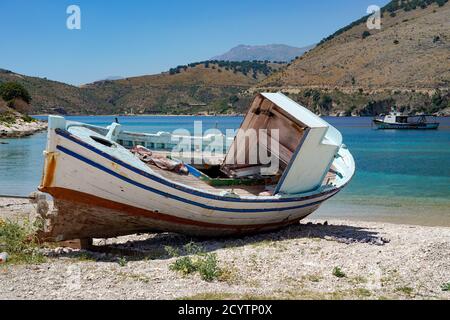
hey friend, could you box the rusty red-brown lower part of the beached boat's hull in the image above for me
[41,189,317,241]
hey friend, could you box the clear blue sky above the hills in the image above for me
[0,0,388,85]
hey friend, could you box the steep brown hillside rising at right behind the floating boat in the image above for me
[252,0,450,114]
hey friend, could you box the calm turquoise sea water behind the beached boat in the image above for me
[0,116,450,226]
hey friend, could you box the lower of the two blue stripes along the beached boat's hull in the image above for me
[56,145,333,213]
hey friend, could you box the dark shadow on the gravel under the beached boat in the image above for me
[50,222,389,262]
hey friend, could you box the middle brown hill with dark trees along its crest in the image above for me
[83,61,283,114]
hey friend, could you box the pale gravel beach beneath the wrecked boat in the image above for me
[0,199,450,299]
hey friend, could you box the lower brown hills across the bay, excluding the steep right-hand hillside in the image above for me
[0,61,285,115]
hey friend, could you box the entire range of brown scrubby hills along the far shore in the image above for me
[0,0,450,115]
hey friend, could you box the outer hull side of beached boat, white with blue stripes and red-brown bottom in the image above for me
[39,130,340,241]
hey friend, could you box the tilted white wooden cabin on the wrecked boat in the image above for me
[222,93,342,194]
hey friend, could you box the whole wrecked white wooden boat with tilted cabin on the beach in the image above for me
[39,93,355,241]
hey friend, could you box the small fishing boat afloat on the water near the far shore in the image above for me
[373,110,439,130]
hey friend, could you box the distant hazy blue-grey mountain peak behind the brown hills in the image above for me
[211,44,314,62]
